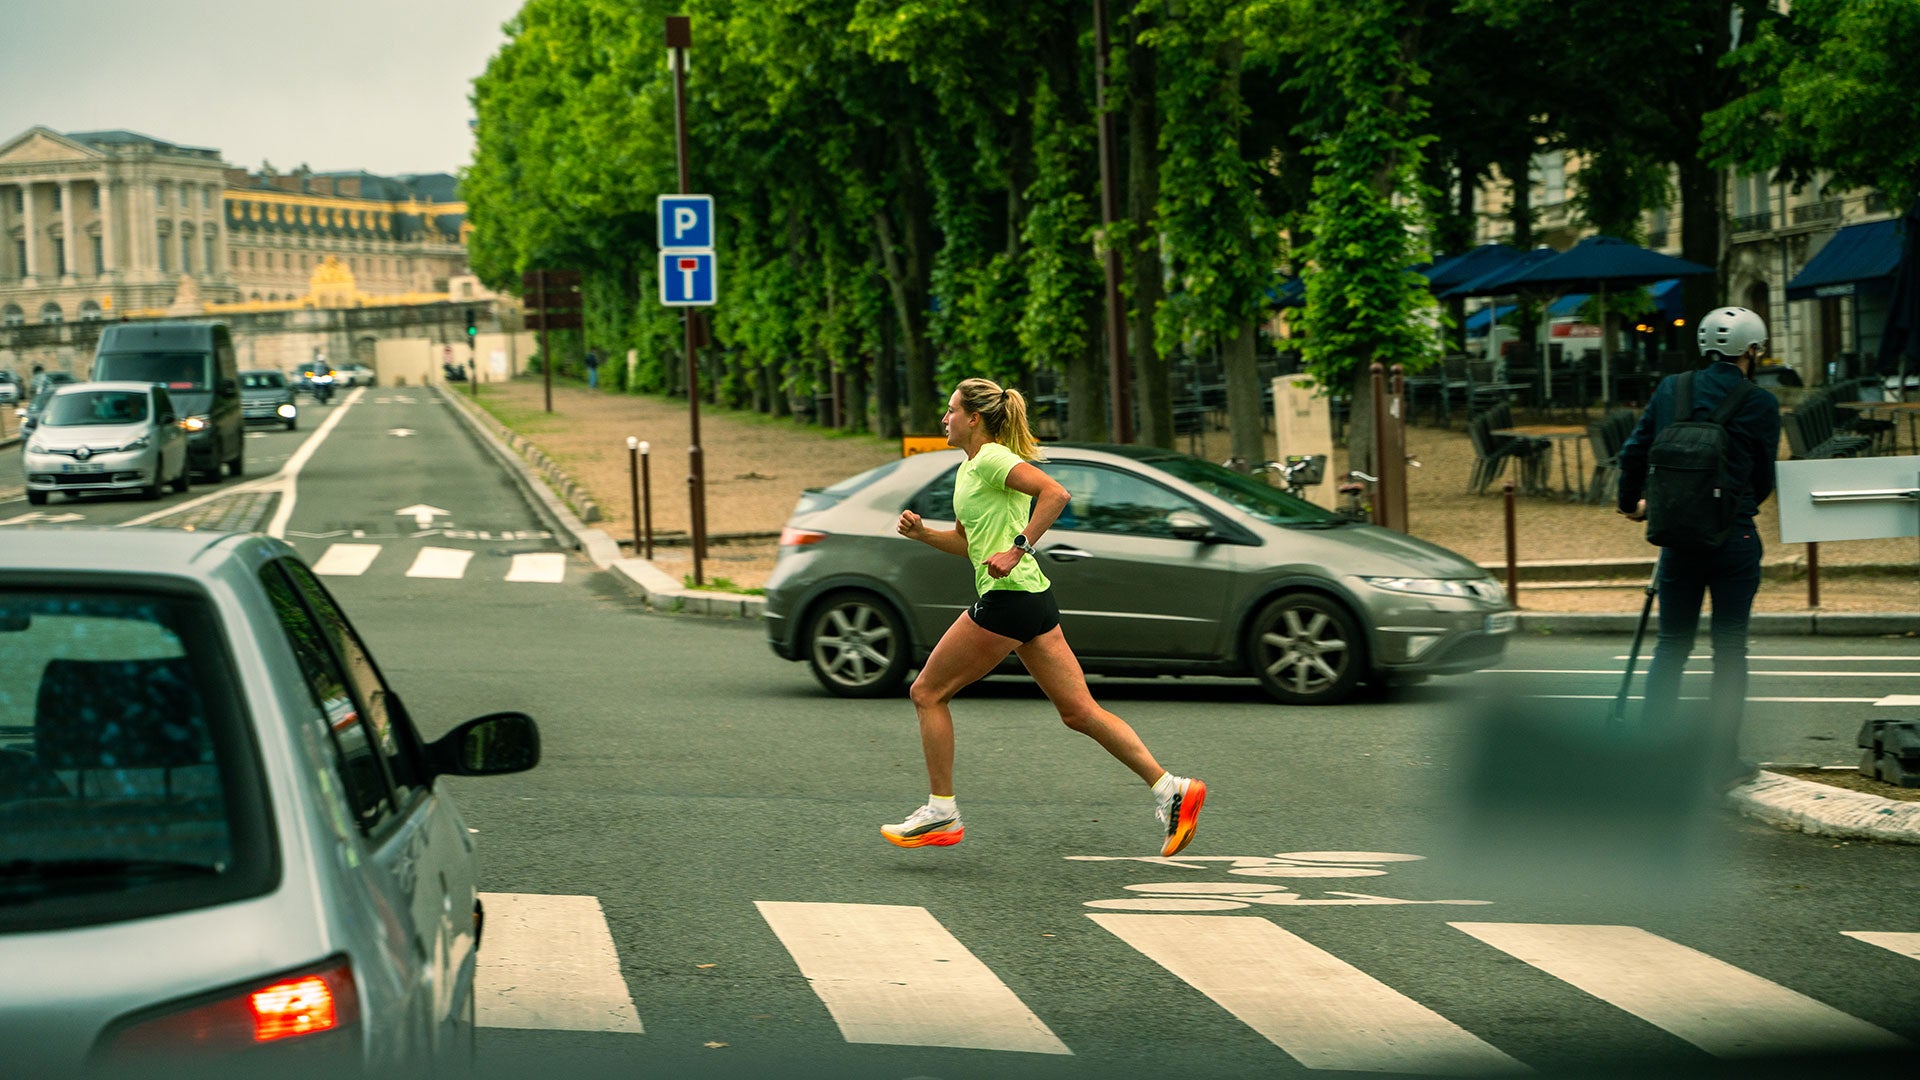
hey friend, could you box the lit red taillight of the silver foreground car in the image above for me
[106,961,359,1059]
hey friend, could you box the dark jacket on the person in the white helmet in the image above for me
[1620,359,1780,525]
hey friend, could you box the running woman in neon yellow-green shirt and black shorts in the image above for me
[879,379,1206,855]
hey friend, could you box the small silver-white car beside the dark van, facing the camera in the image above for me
[21,382,192,505]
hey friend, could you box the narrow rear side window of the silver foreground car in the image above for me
[259,563,394,832]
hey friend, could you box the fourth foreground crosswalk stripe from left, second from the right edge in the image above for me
[1452,922,1907,1057]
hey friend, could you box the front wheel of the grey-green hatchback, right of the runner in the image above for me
[1246,592,1367,705]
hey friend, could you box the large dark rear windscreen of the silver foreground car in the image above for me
[0,584,273,930]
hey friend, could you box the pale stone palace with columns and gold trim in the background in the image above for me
[0,127,467,325]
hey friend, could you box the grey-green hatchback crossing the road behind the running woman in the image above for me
[764,444,1517,705]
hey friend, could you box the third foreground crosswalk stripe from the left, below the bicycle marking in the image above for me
[1089,915,1528,1076]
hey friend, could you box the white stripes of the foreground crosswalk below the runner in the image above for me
[476,894,1920,1076]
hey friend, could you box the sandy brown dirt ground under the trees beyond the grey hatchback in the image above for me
[468,379,1920,611]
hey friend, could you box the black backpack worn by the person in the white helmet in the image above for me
[1647,371,1753,550]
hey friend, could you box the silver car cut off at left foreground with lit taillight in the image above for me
[0,528,540,1076]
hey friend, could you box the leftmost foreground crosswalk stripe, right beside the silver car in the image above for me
[474,892,643,1036]
